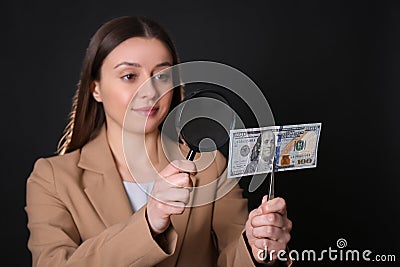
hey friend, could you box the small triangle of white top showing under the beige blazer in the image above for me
[122,181,154,212]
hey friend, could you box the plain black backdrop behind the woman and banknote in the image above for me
[0,1,400,266]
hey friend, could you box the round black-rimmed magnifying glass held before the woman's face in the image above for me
[175,89,236,160]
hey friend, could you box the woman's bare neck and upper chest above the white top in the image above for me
[107,123,162,182]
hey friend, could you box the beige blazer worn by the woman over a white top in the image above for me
[26,127,262,267]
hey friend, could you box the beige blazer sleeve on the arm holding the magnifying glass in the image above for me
[25,159,177,267]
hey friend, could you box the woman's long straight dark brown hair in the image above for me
[58,17,183,154]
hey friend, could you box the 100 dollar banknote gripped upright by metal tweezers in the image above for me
[228,123,321,178]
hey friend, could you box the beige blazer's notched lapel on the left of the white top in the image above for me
[78,125,132,227]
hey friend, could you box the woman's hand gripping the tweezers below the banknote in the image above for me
[246,196,292,263]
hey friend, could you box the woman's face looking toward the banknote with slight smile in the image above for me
[93,37,173,133]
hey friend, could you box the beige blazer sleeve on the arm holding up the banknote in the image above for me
[213,173,292,267]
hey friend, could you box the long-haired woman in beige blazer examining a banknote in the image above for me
[26,17,291,266]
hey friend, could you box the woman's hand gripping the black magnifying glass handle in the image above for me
[147,160,196,235]
